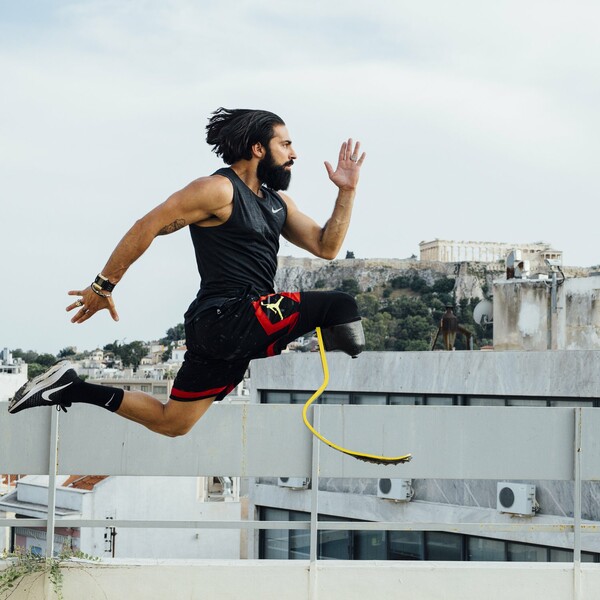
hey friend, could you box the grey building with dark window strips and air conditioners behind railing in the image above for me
[249,350,600,562]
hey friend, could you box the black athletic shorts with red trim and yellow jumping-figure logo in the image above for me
[171,292,360,401]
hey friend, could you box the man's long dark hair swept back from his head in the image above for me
[206,108,285,165]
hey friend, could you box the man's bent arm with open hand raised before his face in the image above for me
[281,138,366,260]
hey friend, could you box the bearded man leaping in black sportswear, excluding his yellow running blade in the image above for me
[8,108,365,437]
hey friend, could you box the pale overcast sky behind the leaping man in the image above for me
[0,0,600,353]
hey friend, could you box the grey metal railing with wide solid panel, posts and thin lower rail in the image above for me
[0,404,600,563]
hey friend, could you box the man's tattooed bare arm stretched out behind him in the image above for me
[67,176,233,323]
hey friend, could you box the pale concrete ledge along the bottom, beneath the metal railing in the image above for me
[0,560,600,600]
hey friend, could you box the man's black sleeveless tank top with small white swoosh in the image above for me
[188,168,287,312]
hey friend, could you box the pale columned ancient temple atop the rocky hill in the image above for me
[419,239,562,262]
